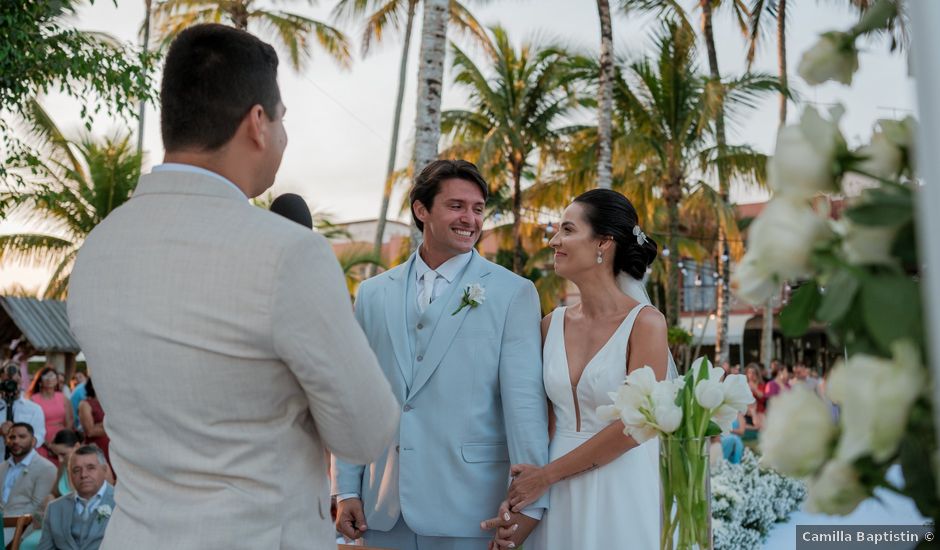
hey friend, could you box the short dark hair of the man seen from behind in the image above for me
[160,23,281,152]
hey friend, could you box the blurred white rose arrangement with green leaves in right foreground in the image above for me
[732,0,940,532]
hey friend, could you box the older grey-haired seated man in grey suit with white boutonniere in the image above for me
[38,445,114,550]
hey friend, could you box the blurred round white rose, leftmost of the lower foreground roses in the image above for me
[760,386,836,477]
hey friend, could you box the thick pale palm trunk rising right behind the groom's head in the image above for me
[411,0,450,250]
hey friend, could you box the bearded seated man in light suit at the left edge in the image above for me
[0,422,56,540]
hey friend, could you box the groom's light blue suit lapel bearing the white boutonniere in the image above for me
[408,250,490,399]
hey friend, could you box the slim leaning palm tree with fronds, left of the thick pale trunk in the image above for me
[333,0,488,272]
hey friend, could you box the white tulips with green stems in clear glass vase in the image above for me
[598,358,754,550]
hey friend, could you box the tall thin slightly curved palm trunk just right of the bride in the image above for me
[701,0,731,365]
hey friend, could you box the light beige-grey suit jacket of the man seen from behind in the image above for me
[68,172,399,550]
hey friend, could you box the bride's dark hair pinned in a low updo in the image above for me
[574,189,657,279]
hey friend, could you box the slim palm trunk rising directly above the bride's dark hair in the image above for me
[597,0,614,189]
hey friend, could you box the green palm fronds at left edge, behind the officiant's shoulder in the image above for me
[0,100,142,298]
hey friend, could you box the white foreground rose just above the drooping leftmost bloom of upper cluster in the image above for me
[747,199,832,280]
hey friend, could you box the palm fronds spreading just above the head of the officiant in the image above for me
[152,0,352,71]
